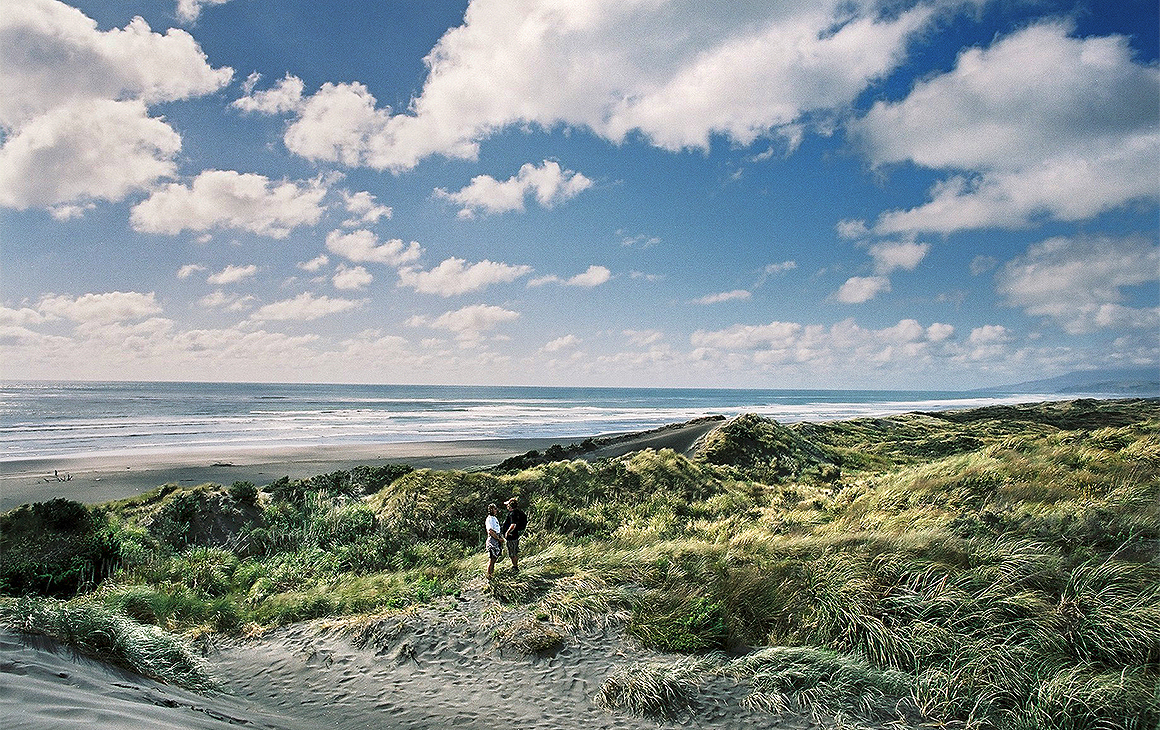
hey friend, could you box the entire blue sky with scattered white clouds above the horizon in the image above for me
[0,0,1160,390]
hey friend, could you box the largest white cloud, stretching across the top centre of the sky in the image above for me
[235,0,936,169]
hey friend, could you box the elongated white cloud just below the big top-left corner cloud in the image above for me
[130,169,326,238]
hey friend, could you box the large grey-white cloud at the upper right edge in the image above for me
[851,21,1160,234]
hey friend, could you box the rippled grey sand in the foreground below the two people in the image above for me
[0,578,815,730]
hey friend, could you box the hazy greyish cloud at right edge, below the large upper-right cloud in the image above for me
[995,237,1160,334]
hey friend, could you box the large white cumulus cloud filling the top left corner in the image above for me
[0,0,233,211]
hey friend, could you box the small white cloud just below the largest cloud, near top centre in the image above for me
[435,160,593,218]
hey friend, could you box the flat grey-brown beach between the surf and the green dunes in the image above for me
[0,421,720,512]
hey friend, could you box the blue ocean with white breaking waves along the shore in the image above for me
[0,381,1058,462]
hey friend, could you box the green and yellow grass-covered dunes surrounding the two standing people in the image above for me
[0,399,1160,730]
